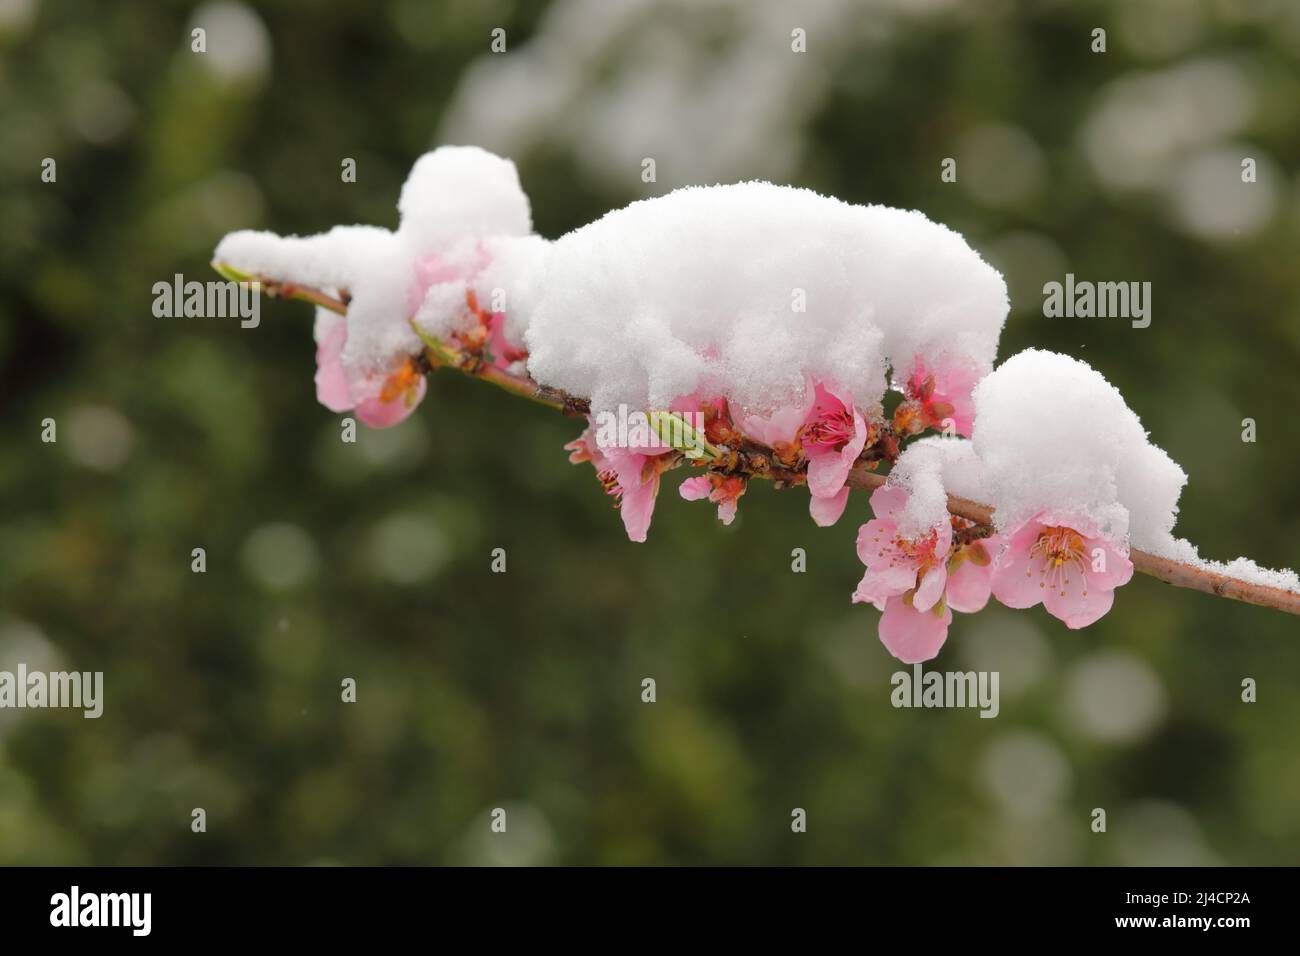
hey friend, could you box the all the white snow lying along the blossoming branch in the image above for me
[205,147,1300,592]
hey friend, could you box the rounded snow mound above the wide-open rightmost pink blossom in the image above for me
[971,349,1187,550]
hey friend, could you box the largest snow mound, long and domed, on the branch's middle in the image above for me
[519,182,1008,412]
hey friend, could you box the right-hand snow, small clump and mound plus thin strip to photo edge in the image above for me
[889,349,1300,592]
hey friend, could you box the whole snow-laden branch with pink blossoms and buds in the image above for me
[213,147,1300,662]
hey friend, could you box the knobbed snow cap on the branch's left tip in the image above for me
[215,146,542,373]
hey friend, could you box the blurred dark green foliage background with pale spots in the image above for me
[0,0,1300,864]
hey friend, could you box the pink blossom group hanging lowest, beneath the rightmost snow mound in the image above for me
[853,485,1134,663]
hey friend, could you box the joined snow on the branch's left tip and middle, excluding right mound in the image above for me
[216,154,1008,412]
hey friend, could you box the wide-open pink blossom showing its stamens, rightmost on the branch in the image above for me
[993,512,1134,628]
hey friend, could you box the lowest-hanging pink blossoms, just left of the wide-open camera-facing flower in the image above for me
[853,485,1002,663]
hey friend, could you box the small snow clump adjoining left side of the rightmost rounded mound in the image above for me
[889,436,988,537]
